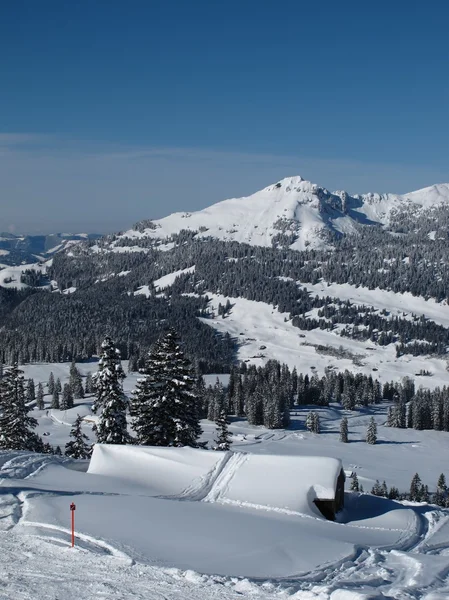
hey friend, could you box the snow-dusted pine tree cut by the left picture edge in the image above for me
[0,363,42,450]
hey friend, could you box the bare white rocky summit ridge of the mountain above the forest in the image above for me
[112,176,449,250]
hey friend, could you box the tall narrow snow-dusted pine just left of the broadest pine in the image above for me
[92,337,131,444]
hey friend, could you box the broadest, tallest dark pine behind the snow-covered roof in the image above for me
[131,330,201,448]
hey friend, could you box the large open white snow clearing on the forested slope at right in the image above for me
[201,288,448,389]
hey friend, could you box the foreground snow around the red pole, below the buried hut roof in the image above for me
[0,452,449,600]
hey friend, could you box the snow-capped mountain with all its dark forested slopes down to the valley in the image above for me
[0,177,449,370]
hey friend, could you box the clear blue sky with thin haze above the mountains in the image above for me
[0,0,449,232]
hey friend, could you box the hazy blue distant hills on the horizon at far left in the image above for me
[0,232,101,266]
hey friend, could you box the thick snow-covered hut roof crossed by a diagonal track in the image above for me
[88,444,342,517]
